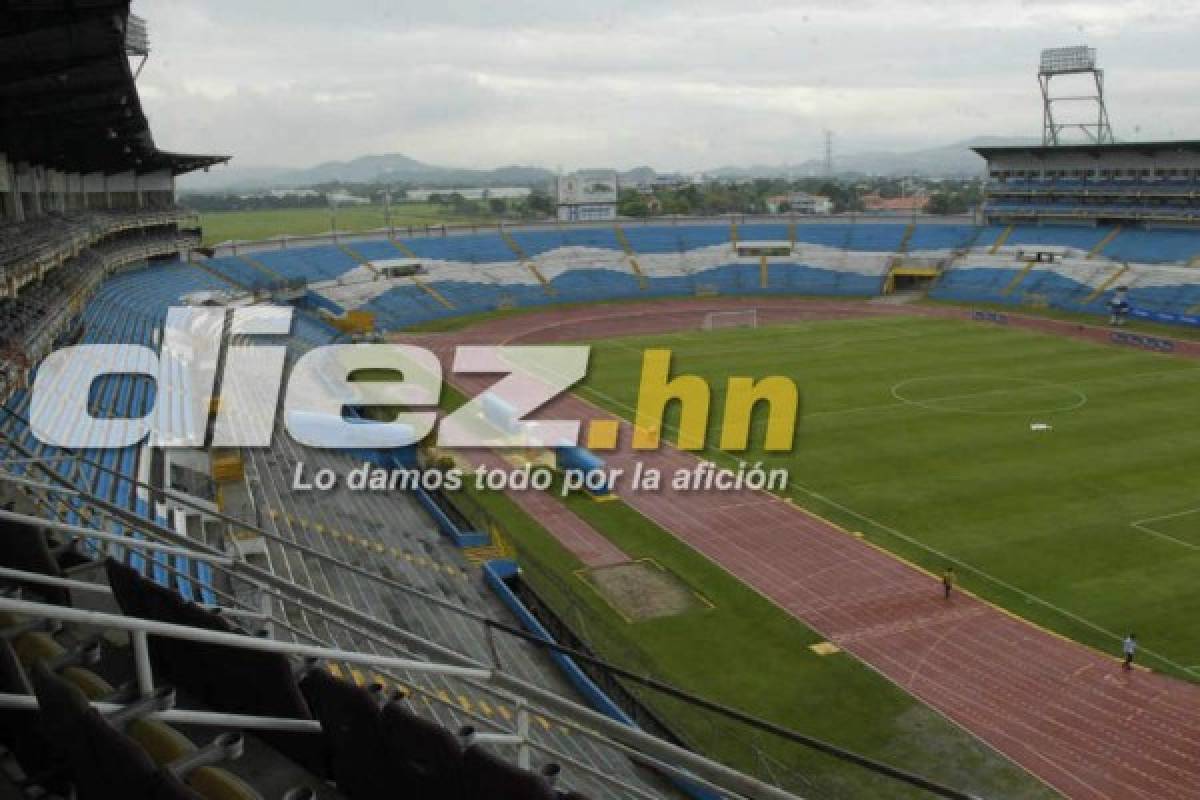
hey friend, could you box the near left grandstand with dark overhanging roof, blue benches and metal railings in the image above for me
[0,0,816,799]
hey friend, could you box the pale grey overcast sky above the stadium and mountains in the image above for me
[133,0,1200,170]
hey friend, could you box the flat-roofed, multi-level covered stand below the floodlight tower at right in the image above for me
[974,140,1200,224]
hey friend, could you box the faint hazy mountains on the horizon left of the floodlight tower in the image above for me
[708,137,1037,178]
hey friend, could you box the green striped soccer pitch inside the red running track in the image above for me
[577,317,1200,679]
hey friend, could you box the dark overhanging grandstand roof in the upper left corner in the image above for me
[0,0,229,175]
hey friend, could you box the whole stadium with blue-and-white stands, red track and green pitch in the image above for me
[0,6,1200,800]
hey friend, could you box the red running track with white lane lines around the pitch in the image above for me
[408,299,1200,800]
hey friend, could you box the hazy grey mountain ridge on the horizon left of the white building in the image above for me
[179,154,553,192]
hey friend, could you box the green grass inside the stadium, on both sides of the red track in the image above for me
[441,311,1200,798]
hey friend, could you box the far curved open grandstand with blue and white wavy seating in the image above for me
[223,218,1200,330]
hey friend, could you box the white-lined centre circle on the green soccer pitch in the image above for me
[892,374,1087,416]
